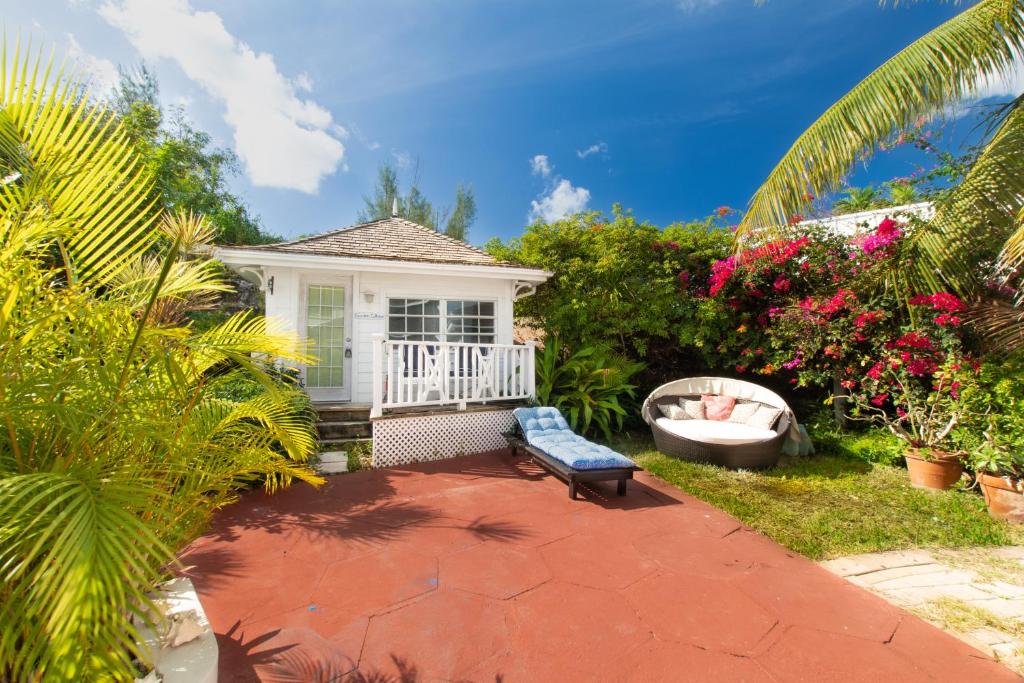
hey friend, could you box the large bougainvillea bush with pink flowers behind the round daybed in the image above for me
[708,219,903,388]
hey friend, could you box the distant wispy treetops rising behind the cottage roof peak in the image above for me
[357,163,476,241]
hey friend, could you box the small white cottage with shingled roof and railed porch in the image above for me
[215,216,551,464]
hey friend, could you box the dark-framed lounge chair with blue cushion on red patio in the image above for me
[505,408,640,500]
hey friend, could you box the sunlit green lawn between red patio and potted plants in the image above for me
[614,435,1024,560]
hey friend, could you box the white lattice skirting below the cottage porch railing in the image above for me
[374,410,515,467]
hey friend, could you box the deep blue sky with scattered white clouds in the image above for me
[4,0,1015,244]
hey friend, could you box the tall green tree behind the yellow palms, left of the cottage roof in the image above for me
[111,66,280,244]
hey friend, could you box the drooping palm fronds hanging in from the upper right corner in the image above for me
[737,0,1024,295]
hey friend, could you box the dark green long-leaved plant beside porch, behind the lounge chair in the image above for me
[537,337,643,439]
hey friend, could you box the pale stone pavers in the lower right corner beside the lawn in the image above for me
[821,548,1024,671]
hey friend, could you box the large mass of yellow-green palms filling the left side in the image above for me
[0,45,317,681]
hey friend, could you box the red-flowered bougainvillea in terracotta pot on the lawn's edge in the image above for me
[851,293,978,489]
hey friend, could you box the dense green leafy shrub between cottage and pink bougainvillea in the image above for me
[485,206,731,375]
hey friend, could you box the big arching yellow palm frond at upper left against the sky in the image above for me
[0,35,157,284]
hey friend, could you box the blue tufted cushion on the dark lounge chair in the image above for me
[512,407,635,470]
